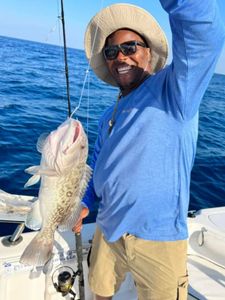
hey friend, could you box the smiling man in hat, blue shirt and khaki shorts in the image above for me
[74,0,225,300]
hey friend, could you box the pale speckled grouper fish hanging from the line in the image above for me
[20,118,91,266]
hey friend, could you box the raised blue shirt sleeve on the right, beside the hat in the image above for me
[160,0,225,119]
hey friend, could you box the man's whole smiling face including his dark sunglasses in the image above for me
[103,29,151,96]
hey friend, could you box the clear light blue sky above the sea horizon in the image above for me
[0,0,225,74]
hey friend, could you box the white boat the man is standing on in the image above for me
[0,191,225,300]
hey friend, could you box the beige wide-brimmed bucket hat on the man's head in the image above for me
[84,3,168,86]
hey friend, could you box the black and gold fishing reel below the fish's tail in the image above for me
[52,266,79,299]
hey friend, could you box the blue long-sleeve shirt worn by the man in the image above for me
[83,0,225,242]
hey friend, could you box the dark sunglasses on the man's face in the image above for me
[103,41,147,60]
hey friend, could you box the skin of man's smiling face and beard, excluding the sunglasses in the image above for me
[103,29,151,95]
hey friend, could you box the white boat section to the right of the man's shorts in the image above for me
[188,207,225,300]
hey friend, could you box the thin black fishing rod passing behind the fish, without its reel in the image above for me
[60,0,85,300]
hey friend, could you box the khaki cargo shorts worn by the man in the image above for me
[89,228,188,300]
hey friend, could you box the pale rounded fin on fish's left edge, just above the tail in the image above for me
[25,200,42,230]
